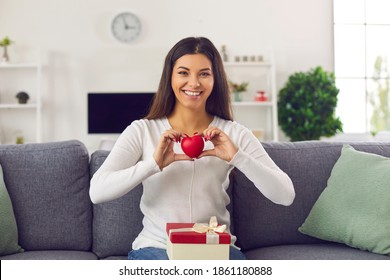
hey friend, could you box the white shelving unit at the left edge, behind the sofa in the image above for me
[0,61,42,144]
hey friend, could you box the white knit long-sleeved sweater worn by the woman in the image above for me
[90,117,295,249]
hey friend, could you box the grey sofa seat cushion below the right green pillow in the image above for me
[244,243,390,260]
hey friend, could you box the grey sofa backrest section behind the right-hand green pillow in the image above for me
[233,141,390,251]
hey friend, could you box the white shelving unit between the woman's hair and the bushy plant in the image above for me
[224,61,278,141]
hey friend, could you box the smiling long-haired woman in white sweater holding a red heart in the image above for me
[90,37,295,259]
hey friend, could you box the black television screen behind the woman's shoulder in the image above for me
[88,92,154,134]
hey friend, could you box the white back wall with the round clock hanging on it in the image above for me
[0,0,333,150]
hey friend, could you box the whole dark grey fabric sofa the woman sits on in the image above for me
[0,140,390,260]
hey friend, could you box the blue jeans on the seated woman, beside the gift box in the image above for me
[127,246,246,260]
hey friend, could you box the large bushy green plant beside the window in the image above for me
[278,66,342,141]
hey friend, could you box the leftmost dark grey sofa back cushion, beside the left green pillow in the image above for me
[0,140,92,251]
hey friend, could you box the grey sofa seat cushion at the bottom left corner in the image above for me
[0,250,98,260]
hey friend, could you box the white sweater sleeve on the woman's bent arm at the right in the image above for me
[229,127,295,206]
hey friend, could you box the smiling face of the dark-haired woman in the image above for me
[171,54,214,110]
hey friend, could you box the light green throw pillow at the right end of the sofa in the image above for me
[299,145,390,255]
